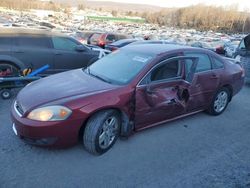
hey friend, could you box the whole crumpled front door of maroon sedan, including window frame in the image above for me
[135,56,198,129]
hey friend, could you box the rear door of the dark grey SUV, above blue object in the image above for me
[12,35,54,75]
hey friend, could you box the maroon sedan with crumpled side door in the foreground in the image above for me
[11,44,244,154]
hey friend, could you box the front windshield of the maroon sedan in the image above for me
[86,50,153,85]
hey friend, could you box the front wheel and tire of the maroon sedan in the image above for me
[83,110,121,155]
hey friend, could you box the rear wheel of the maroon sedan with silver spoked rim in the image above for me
[208,87,230,116]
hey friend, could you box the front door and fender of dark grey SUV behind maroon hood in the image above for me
[52,37,97,72]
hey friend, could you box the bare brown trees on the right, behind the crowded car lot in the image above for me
[139,4,250,33]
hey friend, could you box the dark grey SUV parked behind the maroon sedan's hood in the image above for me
[0,28,100,76]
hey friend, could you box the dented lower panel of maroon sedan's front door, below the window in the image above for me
[135,80,189,128]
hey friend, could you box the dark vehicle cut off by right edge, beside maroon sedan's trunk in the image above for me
[235,34,250,83]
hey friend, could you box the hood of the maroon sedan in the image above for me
[17,69,118,113]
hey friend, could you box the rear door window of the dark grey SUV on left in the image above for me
[16,36,50,48]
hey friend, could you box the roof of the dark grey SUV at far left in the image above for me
[0,27,67,36]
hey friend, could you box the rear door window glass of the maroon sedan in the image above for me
[185,53,212,72]
